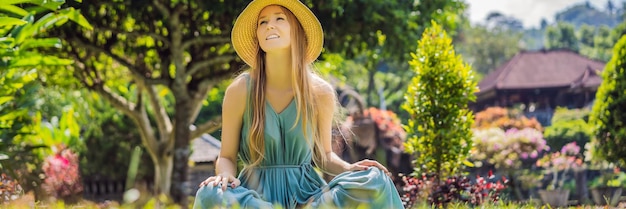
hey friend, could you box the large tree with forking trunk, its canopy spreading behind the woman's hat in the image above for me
[53,0,464,206]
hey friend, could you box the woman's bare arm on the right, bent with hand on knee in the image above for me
[313,78,389,175]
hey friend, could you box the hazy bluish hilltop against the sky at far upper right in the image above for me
[554,3,622,28]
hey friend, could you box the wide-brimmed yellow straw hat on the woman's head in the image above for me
[231,0,324,66]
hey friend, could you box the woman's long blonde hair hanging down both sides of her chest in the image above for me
[248,6,327,166]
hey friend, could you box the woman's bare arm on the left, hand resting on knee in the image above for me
[200,76,247,190]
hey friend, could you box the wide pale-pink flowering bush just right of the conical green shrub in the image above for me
[469,128,550,170]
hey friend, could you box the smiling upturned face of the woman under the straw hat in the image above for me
[256,5,291,53]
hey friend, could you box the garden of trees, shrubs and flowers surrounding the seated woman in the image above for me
[0,0,626,208]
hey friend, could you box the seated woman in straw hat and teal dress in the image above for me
[194,0,403,208]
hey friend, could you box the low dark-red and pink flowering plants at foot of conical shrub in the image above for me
[402,171,508,208]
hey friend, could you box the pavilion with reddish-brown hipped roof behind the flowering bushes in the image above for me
[471,50,605,125]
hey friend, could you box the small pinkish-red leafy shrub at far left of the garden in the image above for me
[42,146,83,203]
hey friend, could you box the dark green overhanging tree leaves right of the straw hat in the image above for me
[312,0,466,60]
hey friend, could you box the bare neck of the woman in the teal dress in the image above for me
[265,52,292,90]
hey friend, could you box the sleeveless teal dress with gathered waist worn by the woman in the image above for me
[194,78,403,209]
